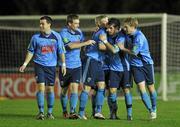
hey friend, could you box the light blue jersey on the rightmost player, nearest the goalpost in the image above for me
[129,29,154,66]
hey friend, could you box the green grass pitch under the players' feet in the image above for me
[0,99,180,127]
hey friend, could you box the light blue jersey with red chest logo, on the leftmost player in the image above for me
[28,31,65,66]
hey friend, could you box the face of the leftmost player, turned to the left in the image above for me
[39,19,51,33]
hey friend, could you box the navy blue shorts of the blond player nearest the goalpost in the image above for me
[131,64,155,85]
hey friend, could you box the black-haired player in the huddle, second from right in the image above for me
[102,18,132,120]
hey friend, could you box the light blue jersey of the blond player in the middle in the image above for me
[86,28,106,62]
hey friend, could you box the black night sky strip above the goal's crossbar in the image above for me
[0,0,180,15]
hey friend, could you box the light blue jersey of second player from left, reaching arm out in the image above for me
[60,27,84,68]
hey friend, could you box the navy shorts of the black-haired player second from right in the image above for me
[109,71,132,88]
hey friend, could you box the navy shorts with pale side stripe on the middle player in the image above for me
[83,58,105,87]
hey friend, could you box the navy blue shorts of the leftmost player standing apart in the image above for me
[35,63,56,86]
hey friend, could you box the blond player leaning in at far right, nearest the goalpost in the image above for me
[123,17,157,119]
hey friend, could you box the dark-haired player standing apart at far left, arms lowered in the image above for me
[19,16,66,120]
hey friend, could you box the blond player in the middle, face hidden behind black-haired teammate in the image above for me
[79,15,108,119]
